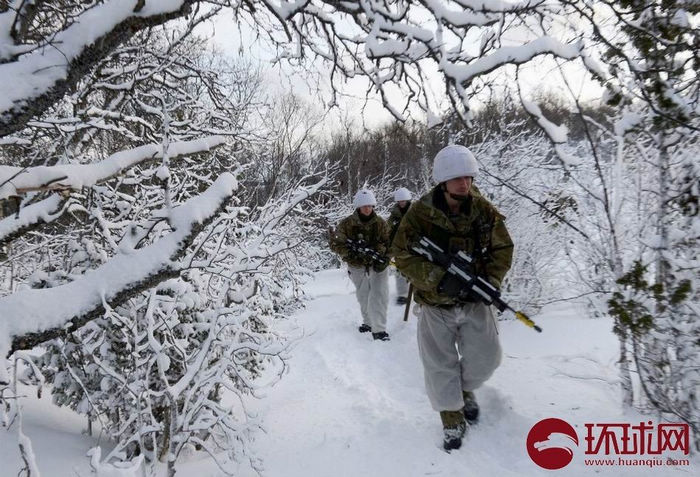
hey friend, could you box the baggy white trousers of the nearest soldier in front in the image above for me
[415,303,501,411]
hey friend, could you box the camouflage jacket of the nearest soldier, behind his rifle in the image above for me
[391,187,513,305]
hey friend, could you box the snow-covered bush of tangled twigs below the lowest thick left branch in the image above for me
[30,172,324,473]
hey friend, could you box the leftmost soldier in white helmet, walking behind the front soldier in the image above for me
[330,189,389,341]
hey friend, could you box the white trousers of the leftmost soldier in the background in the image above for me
[348,265,389,333]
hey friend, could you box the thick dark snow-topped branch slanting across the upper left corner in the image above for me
[0,0,196,137]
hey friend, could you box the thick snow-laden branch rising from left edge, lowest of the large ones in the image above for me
[0,173,237,381]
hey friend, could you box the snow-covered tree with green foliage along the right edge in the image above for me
[578,1,700,440]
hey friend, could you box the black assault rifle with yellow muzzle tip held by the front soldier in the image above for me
[412,237,542,333]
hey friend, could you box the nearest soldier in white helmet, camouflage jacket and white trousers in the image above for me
[391,146,513,451]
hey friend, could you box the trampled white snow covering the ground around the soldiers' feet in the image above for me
[0,270,700,477]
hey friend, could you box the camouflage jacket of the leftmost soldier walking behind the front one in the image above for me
[330,210,389,267]
